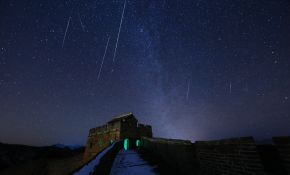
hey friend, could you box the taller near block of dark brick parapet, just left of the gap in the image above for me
[195,137,265,174]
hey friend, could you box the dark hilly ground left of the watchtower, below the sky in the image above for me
[0,143,84,175]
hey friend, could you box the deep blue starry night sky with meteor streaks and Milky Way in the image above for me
[0,0,290,145]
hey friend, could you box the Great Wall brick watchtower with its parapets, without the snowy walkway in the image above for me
[72,113,290,175]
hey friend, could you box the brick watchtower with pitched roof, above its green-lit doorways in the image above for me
[84,113,152,162]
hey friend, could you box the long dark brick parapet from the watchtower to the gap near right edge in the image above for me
[142,137,266,175]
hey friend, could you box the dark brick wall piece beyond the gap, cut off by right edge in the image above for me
[273,136,290,174]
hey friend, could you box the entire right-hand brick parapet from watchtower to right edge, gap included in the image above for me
[141,137,290,175]
